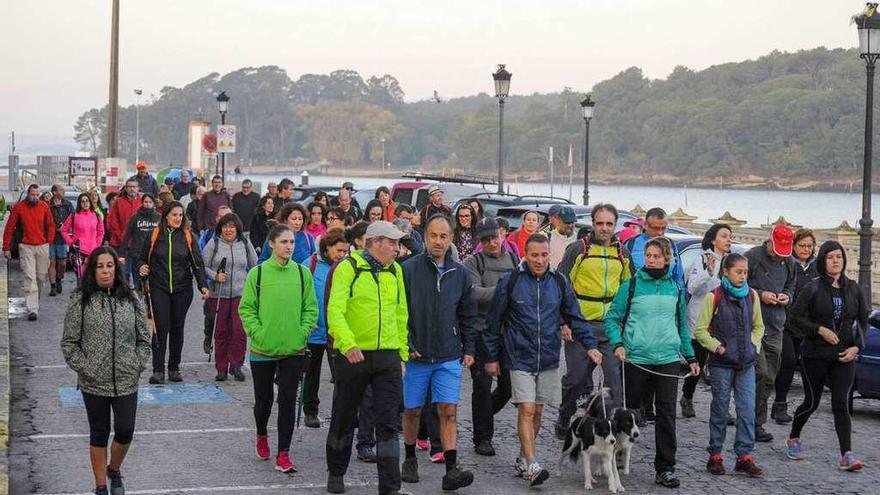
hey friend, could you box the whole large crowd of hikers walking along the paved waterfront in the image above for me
[3,167,870,495]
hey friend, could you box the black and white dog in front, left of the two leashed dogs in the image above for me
[557,394,624,493]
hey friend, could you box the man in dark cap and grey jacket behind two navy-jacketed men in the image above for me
[464,217,519,456]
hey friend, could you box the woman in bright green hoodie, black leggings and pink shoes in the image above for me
[238,225,318,473]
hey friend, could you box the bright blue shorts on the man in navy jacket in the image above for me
[403,359,461,409]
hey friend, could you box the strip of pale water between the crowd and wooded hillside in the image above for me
[250,174,880,229]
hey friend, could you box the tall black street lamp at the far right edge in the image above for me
[854,3,880,304]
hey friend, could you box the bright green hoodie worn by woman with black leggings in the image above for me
[238,256,318,358]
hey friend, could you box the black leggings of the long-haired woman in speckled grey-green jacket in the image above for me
[82,392,137,448]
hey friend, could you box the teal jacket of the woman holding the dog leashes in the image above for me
[605,269,694,365]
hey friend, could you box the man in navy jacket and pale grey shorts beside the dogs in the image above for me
[483,234,602,486]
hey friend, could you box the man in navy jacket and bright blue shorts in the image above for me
[401,215,477,490]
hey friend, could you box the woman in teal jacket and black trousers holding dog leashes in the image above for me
[605,237,700,488]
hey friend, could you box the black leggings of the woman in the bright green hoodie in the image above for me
[250,356,306,452]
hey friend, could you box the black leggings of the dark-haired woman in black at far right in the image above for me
[789,358,856,454]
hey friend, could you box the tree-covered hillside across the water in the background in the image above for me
[74,48,880,178]
